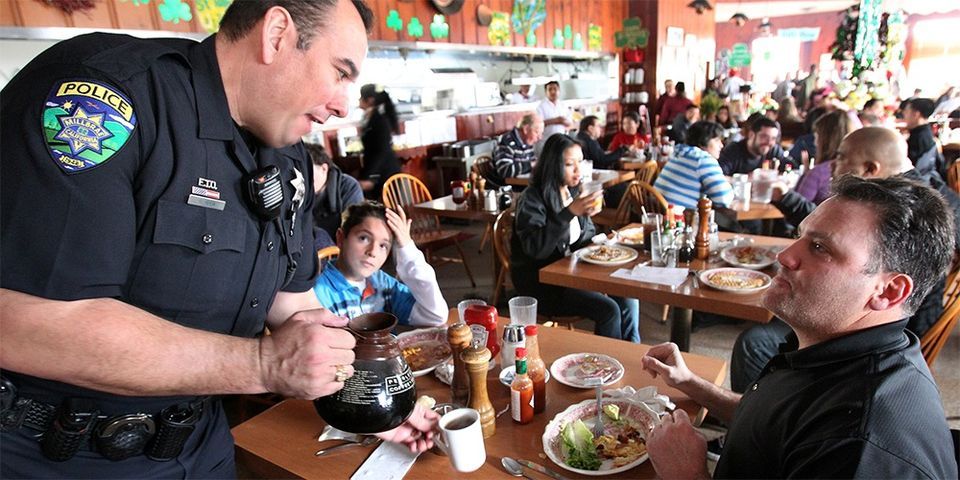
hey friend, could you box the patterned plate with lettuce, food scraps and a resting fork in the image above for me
[543,399,660,476]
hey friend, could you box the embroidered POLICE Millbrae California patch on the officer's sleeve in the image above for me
[41,79,137,173]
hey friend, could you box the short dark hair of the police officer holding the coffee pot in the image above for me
[220,0,374,50]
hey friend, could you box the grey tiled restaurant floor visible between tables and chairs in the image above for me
[437,224,960,428]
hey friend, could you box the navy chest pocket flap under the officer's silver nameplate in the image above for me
[153,200,246,253]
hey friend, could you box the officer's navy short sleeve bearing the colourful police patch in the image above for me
[0,67,142,300]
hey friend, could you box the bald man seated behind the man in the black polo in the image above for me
[730,127,960,393]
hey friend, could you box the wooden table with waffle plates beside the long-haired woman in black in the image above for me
[540,231,793,352]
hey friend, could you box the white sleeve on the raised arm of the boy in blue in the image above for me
[394,244,448,327]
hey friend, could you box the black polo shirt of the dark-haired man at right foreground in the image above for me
[714,320,957,479]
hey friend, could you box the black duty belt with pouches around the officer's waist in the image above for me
[0,377,212,462]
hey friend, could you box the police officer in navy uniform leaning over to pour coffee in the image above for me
[0,0,436,478]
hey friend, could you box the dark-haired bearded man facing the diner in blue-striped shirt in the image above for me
[718,115,796,176]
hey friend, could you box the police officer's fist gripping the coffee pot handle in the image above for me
[260,309,357,400]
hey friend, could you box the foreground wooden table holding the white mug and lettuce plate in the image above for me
[233,316,726,479]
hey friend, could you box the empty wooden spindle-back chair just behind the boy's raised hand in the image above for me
[383,173,477,287]
